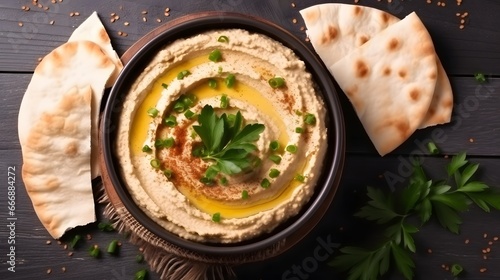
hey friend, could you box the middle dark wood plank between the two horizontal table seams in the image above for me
[0,74,500,156]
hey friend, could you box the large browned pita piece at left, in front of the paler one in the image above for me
[18,41,115,238]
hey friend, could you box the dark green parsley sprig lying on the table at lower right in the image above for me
[330,153,500,280]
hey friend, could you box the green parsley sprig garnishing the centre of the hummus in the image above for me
[193,105,264,184]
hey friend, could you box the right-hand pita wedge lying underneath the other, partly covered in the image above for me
[300,3,453,128]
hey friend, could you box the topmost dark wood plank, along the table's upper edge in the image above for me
[0,0,500,75]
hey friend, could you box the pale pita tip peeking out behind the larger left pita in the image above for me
[68,12,123,88]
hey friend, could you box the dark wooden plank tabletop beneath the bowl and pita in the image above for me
[0,0,500,279]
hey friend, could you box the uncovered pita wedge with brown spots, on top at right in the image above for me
[329,13,438,155]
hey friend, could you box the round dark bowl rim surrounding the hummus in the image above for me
[100,12,345,257]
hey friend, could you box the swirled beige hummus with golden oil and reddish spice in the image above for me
[116,29,327,243]
